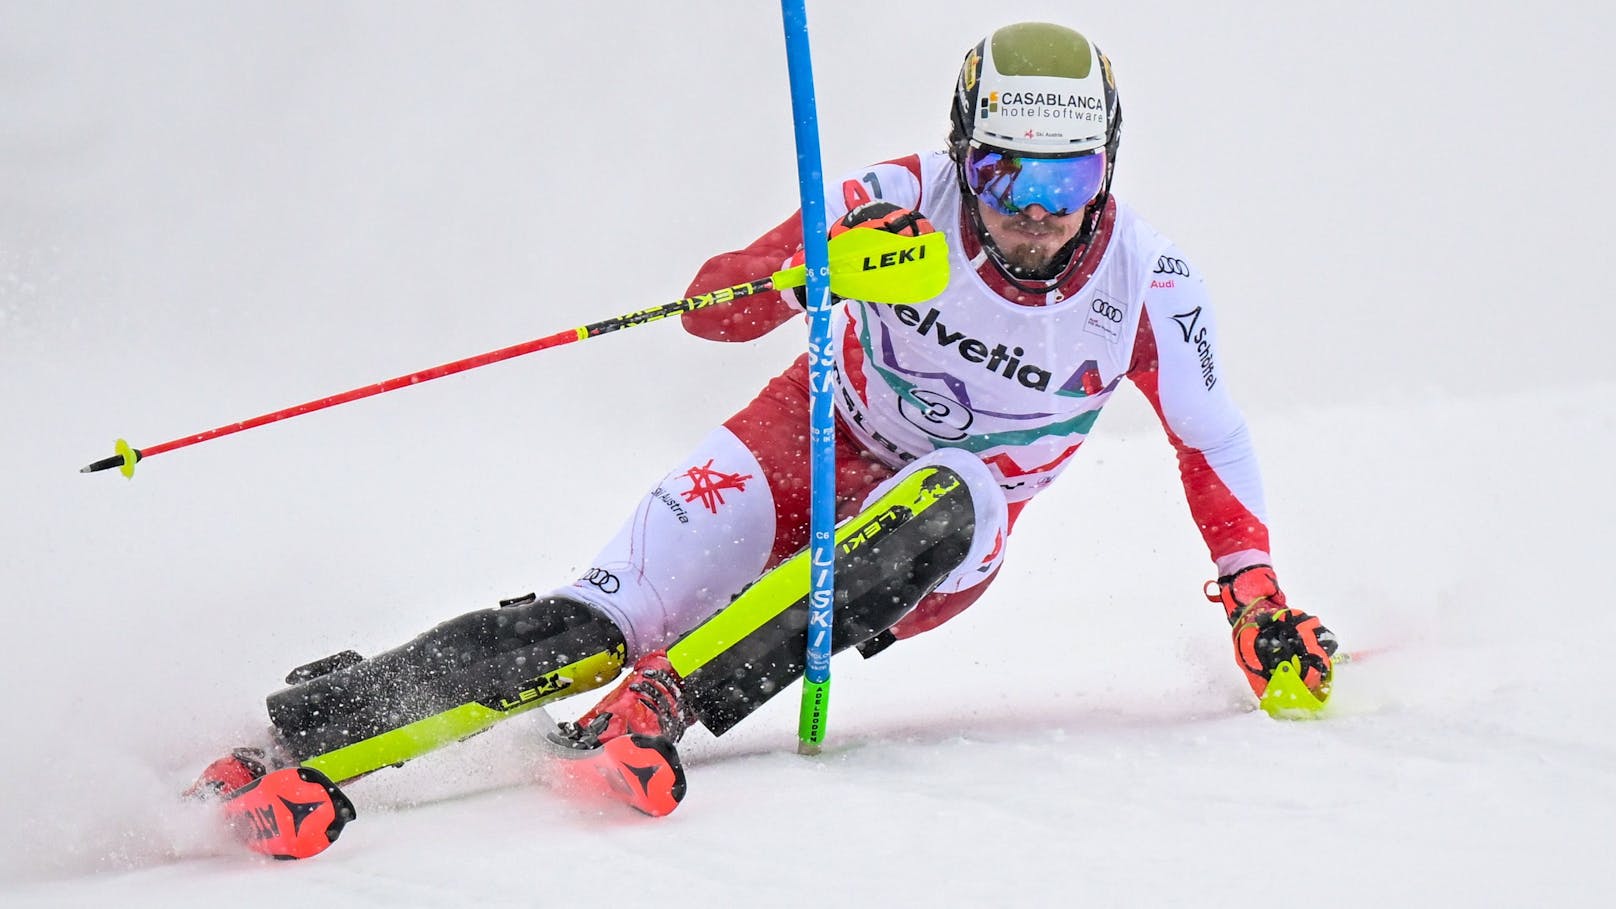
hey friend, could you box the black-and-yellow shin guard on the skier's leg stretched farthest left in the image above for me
[268,595,625,781]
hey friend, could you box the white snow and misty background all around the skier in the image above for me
[0,0,1616,909]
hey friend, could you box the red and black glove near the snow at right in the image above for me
[1206,564,1336,700]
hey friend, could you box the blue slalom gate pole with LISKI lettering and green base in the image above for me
[781,0,835,754]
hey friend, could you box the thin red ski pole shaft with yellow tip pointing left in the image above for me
[79,273,781,477]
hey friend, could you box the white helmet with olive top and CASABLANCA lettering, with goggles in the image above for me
[949,23,1122,291]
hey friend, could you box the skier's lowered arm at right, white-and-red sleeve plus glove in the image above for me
[1128,247,1335,697]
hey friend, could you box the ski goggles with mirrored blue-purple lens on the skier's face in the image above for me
[965,146,1105,215]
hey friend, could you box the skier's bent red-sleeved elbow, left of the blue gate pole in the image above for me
[680,212,803,341]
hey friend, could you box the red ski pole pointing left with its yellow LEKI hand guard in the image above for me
[79,230,949,477]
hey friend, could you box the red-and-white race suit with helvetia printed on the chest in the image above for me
[566,152,1270,652]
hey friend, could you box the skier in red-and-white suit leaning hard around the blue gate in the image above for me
[192,23,1335,856]
